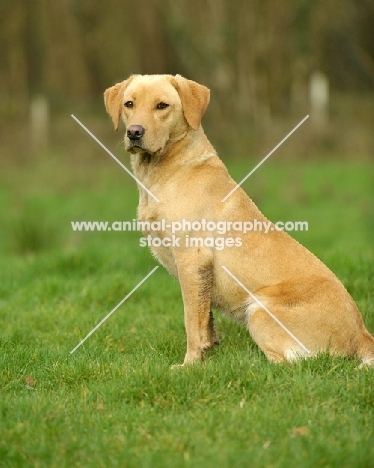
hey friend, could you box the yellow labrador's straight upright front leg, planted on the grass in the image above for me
[177,249,216,365]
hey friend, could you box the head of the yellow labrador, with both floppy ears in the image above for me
[104,75,209,155]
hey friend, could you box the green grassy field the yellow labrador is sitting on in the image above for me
[0,151,374,468]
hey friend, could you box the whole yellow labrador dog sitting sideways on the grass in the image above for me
[104,75,374,365]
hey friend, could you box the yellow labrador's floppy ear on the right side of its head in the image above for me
[174,75,210,130]
